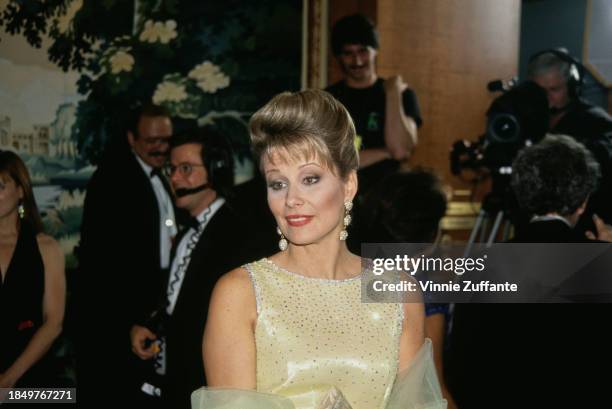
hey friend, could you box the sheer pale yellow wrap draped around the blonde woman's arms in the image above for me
[191,339,446,409]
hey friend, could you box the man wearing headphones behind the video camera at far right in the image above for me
[528,49,612,225]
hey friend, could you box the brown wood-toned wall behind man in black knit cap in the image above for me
[329,0,520,188]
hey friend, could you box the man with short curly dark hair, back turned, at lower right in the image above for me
[446,135,612,408]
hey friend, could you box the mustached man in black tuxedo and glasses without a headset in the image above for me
[75,105,176,407]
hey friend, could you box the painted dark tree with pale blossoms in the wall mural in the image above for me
[0,0,300,163]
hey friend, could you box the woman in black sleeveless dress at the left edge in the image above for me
[0,151,66,388]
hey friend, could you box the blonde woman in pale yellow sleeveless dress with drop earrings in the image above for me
[192,90,445,409]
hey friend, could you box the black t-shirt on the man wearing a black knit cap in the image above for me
[325,78,423,149]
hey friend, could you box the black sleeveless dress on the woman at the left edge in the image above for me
[0,223,52,387]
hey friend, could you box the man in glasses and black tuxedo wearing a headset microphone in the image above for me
[131,127,274,408]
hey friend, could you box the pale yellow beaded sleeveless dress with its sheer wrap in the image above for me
[192,258,446,409]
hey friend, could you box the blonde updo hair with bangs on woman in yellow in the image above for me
[250,89,359,179]
